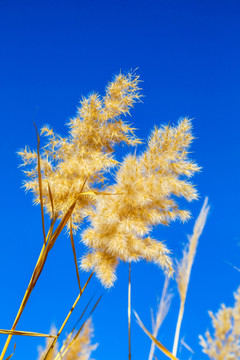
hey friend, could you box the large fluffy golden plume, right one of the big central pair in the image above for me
[81,118,199,287]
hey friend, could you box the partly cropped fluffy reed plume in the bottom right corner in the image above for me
[199,287,240,360]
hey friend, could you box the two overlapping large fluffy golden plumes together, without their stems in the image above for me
[19,73,199,287]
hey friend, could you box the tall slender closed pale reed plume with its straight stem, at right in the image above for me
[172,197,210,356]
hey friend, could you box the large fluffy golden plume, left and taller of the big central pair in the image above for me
[19,73,140,230]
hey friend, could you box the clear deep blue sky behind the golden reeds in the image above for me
[0,0,240,360]
